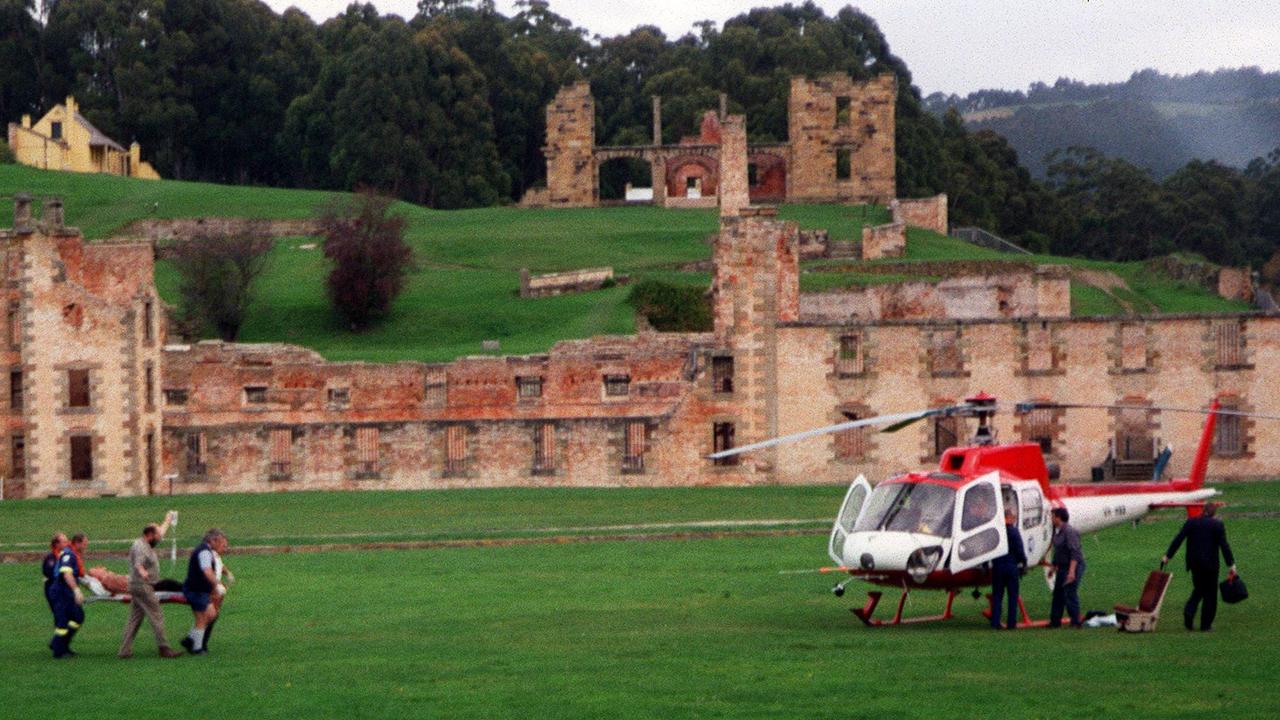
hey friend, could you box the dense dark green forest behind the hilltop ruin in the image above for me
[0,0,1280,265]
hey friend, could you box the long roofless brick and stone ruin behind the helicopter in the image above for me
[0,189,1280,497]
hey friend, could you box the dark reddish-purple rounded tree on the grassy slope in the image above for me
[320,192,413,331]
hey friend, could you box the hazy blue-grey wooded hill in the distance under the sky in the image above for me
[924,68,1280,178]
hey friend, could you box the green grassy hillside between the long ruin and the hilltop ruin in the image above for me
[0,165,1244,361]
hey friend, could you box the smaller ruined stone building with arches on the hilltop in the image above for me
[525,74,896,207]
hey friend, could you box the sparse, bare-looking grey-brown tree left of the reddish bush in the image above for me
[172,234,271,342]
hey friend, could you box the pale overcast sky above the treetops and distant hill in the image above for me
[266,0,1280,95]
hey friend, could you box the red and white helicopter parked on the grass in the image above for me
[709,393,1263,625]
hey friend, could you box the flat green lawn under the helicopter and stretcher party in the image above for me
[0,483,1280,719]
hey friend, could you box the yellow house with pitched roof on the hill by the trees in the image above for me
[9,95,160,179]
